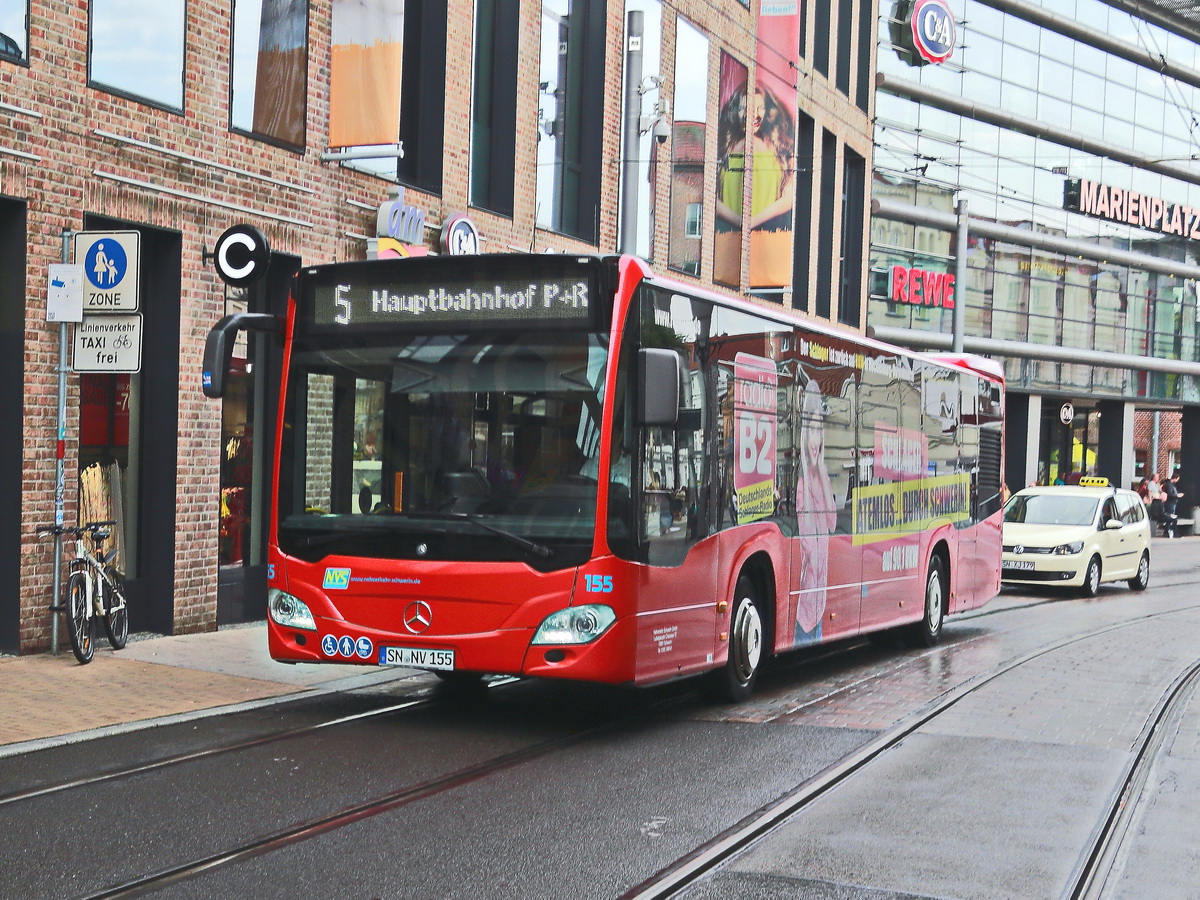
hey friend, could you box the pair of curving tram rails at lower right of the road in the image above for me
[619,604,1200,900]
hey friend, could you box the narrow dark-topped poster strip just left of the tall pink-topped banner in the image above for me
[713,50,750,288]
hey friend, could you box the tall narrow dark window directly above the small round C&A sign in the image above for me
[470,0,520,216]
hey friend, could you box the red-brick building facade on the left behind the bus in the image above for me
[0,0,876,653]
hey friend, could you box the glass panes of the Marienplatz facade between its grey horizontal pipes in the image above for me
[868,0,1200,402]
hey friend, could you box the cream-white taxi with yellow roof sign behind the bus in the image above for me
[1000,479,1151,596]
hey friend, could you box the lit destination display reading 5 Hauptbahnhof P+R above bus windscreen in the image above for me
[313,277,592,326]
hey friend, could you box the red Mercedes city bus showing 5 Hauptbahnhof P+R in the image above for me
[204,254,1003,698]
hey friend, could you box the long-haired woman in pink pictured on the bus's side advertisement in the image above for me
[794,380,838,644]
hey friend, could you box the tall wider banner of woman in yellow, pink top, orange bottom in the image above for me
[748,0,800,288]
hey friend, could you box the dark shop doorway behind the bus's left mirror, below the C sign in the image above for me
[217,253,300,625]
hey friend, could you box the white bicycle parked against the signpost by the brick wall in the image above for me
[37,522,130,662]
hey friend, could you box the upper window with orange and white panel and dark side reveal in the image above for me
[329,0,446,192]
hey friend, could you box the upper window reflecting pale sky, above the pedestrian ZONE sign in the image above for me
[88,0,186,112]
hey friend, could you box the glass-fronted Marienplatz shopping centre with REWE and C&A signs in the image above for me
[866,0,1200,487]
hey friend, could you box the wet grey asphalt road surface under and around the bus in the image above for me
[0,540,1200,900]
